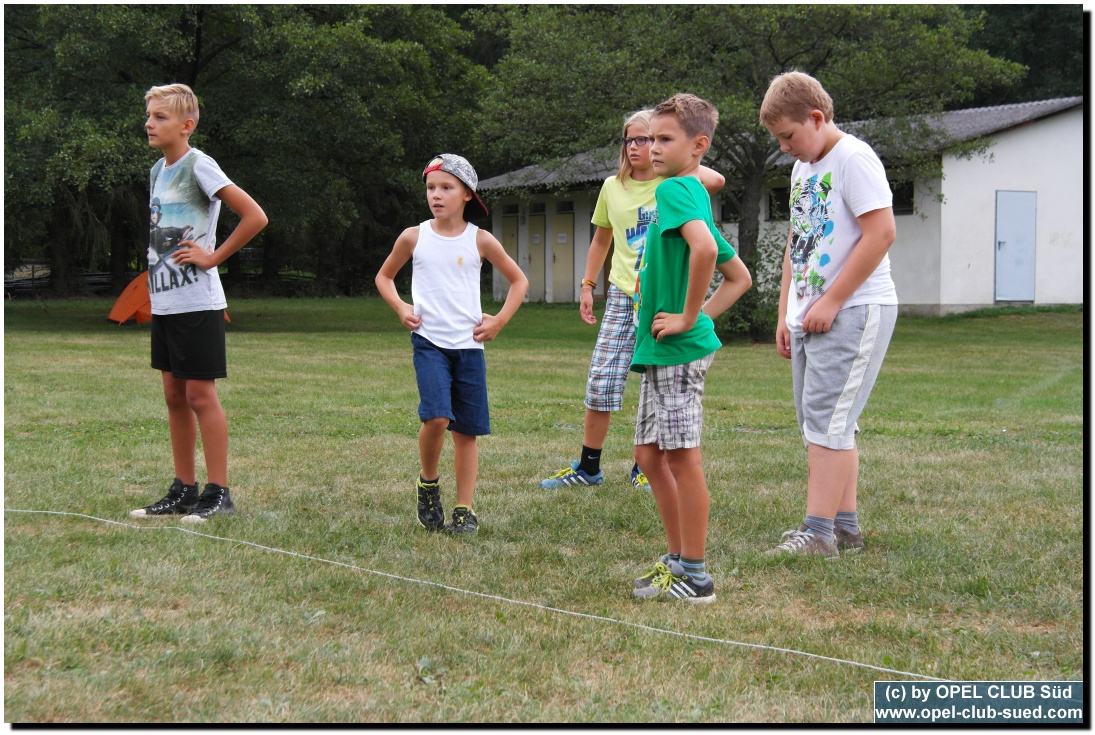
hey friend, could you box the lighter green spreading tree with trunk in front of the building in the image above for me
[477,4,1019,260]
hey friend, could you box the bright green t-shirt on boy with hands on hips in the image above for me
[631,176,735,372]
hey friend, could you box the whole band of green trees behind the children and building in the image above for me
[3,4,1083,294]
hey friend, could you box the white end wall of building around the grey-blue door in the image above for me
[937,107,1084,313]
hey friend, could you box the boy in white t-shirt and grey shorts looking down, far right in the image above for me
[760,71,898,556]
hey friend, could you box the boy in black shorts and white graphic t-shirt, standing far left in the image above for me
[129,84,267,522]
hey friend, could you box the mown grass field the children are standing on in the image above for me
[4,299,1085,723]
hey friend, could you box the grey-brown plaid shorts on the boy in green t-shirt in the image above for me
[635,353,715,450]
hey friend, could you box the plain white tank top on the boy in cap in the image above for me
[411,221,483,349]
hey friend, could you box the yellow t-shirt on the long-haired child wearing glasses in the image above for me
[591,176,665,298]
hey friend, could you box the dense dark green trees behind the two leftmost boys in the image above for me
[4,5,485,291]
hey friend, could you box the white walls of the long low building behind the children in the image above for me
[493,107,1086,314]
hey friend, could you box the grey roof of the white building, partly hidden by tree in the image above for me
[479,96,1084,195]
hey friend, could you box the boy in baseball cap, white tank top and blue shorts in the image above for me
[377,153,529,533]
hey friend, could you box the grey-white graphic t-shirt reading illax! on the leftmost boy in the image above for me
[148,148,232,315]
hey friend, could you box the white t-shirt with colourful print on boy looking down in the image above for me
[786,135,897,336]
